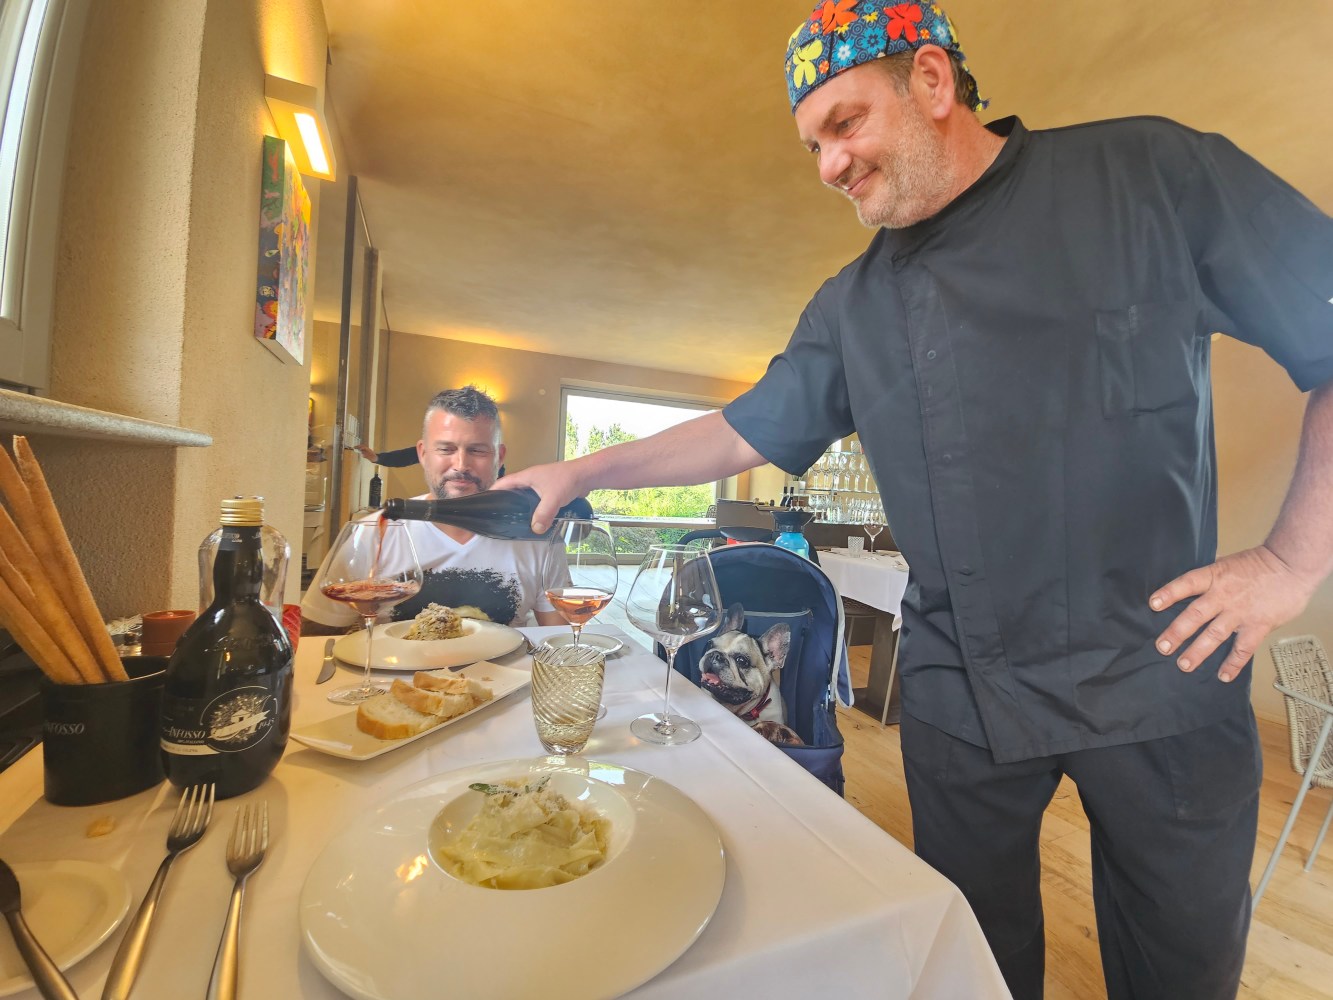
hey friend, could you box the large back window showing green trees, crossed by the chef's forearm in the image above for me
[561,388,717,517]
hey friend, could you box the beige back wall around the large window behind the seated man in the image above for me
[375,332,781,496]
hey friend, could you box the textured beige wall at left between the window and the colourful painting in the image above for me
[33,0,327,616]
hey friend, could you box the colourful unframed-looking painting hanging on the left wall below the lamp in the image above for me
[255,136,311,364]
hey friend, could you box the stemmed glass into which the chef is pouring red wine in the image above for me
[316,517,421,705]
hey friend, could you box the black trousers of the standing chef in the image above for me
[901,708,1262,1000]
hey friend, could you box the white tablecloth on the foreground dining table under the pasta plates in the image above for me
[0,629,1008,1000]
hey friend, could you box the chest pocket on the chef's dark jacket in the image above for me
[1097,301,1202,417]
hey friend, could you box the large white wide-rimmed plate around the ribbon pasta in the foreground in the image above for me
[300,757,725,1000]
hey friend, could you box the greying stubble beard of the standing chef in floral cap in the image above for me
[848,101,952,229]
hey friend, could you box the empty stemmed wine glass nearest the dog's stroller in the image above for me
[625,545,722,747]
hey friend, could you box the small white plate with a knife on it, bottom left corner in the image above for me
[0,861,129,996]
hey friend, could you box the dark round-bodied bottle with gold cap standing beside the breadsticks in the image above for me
[161,497,292,799]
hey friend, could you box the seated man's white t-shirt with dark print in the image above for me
[301,513,569,625]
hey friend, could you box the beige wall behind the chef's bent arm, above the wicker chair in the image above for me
[1213,337,1333,719]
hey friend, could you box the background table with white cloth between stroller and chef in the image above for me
[820,551,908,725]
